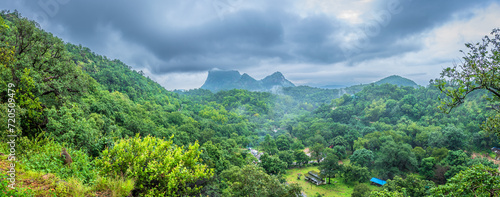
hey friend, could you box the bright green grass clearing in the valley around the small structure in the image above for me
[285,166,378,197]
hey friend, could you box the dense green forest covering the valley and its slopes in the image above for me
[0,11,500,196]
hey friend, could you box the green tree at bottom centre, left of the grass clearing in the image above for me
[221,164,302,197]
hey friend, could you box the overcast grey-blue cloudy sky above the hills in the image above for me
[0,0,500,90]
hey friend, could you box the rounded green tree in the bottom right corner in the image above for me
[431,164,500,196]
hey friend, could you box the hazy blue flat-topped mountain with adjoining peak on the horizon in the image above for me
[201,70,295,92]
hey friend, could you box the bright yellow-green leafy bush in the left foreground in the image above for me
[96,135,213,196]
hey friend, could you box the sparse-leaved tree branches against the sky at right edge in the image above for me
[433,28,500,136]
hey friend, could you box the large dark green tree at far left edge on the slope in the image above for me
[1,12,94,137]
